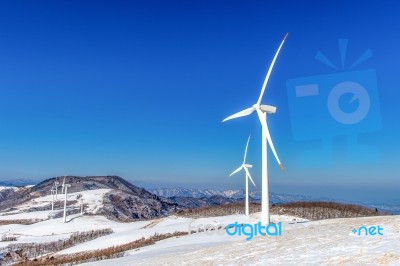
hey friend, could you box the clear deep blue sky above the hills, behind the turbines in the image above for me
[0,1,400,203]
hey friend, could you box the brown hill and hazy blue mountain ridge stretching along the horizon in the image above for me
[0,176,400,218]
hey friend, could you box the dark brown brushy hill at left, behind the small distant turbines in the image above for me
[0,176,179,221]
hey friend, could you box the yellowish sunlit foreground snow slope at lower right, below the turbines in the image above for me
[83,216,400,266]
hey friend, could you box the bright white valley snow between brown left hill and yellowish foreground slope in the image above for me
[0,208,301,254]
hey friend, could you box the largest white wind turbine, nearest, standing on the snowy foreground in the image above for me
[222,33,288,224]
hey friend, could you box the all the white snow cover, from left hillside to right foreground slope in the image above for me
[0,189,400,265]
